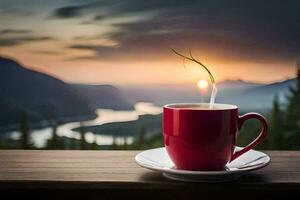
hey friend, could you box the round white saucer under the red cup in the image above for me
[135,147,271,182]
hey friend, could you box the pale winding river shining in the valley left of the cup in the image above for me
[8,102,162,148]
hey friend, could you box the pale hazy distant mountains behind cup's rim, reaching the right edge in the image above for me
[122,79,296,111]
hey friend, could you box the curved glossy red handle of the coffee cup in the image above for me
[230,113,268,162]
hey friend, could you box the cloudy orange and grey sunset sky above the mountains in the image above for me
[0,0,300,85]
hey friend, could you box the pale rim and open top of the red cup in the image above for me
[163,103,238,111]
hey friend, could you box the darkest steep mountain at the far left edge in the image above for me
[0,55,95,125]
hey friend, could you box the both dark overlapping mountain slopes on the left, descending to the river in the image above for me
[0,57,133,127]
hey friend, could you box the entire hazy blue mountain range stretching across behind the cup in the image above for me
[0,57,296,127]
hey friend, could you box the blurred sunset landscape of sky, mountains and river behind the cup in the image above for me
[0,0,300,150]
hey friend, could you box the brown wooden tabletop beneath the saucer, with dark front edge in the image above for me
[0,150,300,199]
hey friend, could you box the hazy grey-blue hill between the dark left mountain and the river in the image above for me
[71,84,133,110]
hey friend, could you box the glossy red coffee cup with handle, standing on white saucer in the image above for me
[163,103,268,171]
